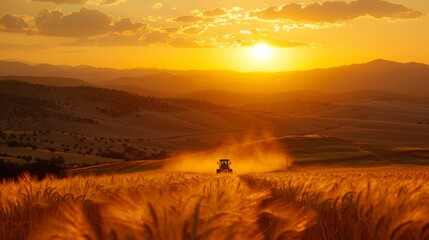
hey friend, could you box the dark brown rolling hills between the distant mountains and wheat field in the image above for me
[0,80,429,171]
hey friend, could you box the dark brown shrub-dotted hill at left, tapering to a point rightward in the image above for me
[0,80,274,137]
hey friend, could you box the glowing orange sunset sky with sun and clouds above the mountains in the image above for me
[0,0,429,71]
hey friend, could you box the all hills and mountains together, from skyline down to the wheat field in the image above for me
[0,60,429,167]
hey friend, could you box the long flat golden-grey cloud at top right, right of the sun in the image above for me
[252,0,423,22]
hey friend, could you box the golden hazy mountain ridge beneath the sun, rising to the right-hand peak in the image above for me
[59,60,429,97]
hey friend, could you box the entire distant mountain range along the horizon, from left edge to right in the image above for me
[0,60,429,97]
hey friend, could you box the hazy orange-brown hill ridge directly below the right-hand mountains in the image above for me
[185,90,429,124]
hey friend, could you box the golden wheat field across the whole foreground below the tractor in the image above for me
[0,166,429,240]
